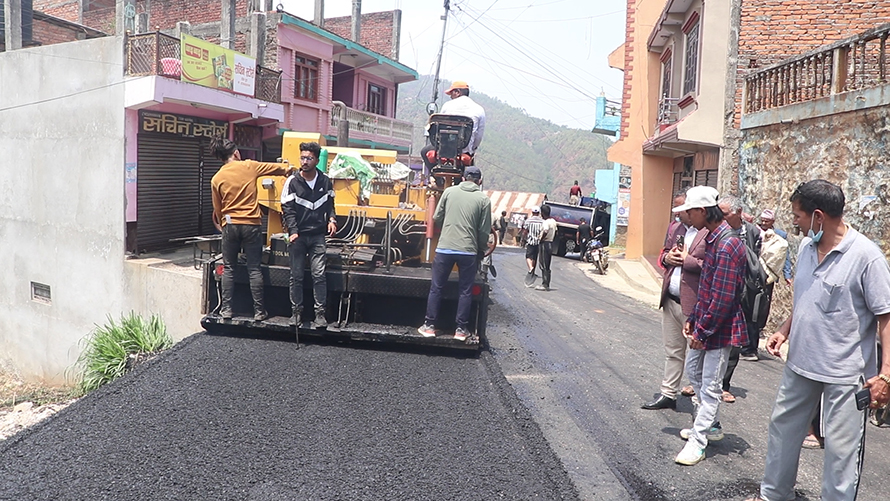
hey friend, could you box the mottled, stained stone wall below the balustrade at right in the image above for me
[739,86,890,323]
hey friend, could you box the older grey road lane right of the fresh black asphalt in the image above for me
[488,249,890,501]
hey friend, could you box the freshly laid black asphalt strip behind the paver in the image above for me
[0,334,577,500]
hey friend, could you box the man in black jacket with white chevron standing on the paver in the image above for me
[281,142,337,329]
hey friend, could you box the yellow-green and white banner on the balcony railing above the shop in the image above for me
[179,34,256,97]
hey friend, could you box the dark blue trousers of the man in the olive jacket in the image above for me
[426,252,478,329]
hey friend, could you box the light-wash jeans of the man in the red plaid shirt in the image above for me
[686,346,732,449]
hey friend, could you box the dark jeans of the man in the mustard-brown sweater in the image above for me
[220,224,265,314]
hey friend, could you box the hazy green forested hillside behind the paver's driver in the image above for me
[398,76,611,202]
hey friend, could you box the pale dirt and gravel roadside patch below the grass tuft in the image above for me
[0,368,76,440]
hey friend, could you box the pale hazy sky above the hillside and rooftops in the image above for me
[276,0,627,130]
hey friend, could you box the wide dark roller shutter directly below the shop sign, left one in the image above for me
[136,134,201,252]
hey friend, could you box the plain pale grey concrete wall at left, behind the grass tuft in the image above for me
[0,37,200,384]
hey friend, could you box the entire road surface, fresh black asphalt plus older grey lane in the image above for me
[0,249,890,501]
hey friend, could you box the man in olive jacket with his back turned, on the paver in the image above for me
[417,165,491,341]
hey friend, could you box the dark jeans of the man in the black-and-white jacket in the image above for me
[288,233,328,312]
